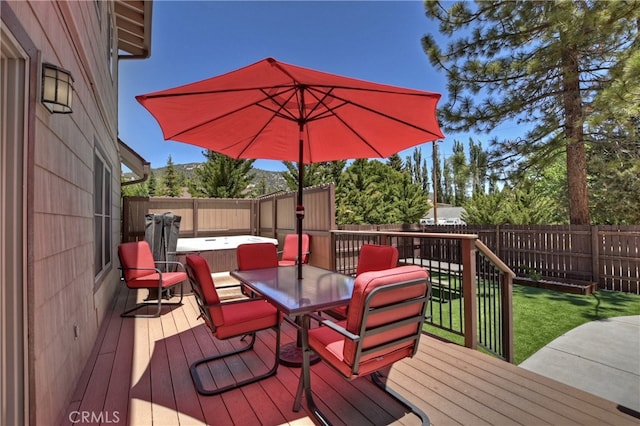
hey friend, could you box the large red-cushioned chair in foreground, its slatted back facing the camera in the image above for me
[294,265,431,425]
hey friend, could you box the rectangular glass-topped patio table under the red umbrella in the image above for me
[231,264,355,367]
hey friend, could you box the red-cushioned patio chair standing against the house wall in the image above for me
[118,241,187,318]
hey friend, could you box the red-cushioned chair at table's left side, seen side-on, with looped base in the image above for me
[187,253,282,395]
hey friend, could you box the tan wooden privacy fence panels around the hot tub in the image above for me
[122,184,335,268]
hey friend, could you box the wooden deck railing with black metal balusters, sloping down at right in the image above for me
[331,231,514,362]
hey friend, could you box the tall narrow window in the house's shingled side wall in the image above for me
[93,151,111,277]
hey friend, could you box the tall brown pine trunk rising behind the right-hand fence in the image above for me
[562,45,590,225]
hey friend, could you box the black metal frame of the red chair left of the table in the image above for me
[187,260,280,395]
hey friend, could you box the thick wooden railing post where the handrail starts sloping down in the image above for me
[461,238,478,349]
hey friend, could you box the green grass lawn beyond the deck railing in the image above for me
[425,284,640,364]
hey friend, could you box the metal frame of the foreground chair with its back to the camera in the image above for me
[293,279,431,426]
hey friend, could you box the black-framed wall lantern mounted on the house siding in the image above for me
[41,63,73,114]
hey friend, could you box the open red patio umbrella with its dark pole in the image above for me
[136,58,444,278]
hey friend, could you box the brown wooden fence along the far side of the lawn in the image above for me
[340,225,640,294]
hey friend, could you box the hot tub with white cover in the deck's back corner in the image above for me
[176,235,278,272]
